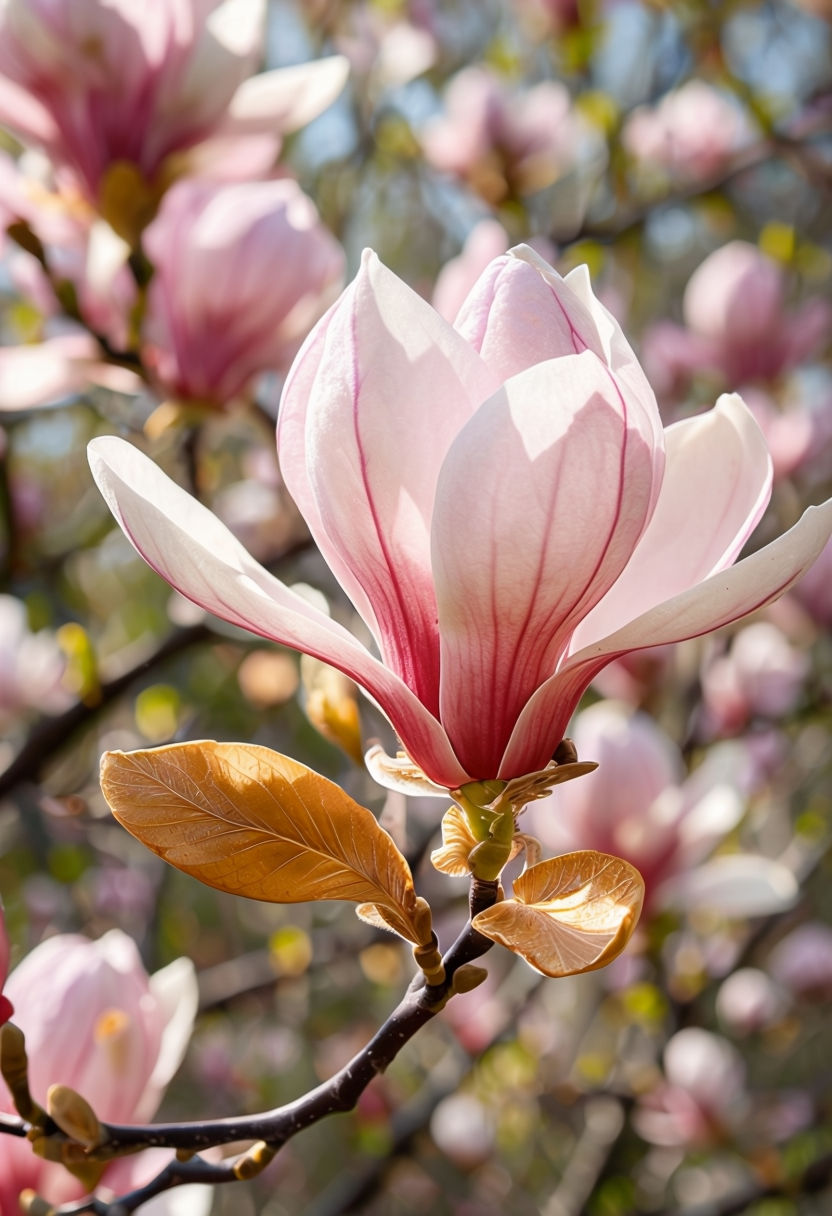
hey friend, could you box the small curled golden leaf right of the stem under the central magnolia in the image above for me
[472,849,645,978]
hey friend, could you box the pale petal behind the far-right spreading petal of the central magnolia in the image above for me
[570,393,771,653]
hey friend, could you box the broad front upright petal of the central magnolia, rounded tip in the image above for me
[433,351,654,777]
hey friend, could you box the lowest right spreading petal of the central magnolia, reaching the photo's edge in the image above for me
[500,499,832,777]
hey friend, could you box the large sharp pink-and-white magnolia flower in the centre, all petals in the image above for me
[90,248,832,792]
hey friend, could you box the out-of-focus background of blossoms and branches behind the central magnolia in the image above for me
[0,0,832,1216]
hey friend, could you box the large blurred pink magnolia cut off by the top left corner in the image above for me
[0,0,345,206]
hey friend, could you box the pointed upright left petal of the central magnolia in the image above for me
[277,253,496,713]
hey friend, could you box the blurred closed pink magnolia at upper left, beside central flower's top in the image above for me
[142,178,344,406]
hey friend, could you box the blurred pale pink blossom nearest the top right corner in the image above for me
[622,80,754,179]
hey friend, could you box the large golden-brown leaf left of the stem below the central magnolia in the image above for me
[101,741,423,942]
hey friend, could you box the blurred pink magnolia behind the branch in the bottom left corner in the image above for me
[0,929,200,1216]
